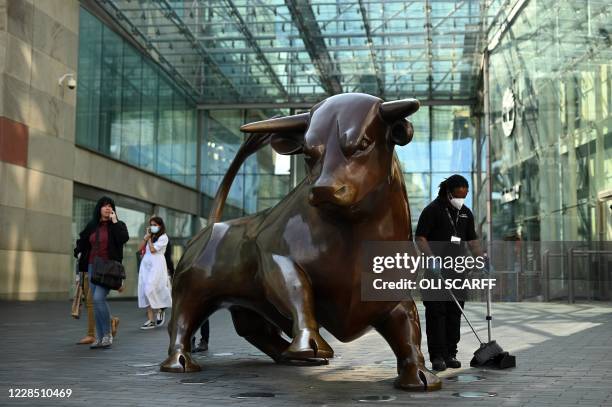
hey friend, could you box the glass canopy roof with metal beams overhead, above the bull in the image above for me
[97,0,501,105]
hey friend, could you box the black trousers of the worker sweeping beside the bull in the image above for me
[423,300,465,360]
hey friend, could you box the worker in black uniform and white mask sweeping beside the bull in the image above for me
[415,174,483,371]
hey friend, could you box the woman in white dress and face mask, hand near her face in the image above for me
[138,216,172,329]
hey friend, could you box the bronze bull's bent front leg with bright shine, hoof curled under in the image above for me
[260,253,334,359]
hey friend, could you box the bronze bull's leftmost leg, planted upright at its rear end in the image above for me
[160,285,217,373]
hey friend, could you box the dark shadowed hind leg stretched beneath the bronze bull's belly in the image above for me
[230,306,289,362]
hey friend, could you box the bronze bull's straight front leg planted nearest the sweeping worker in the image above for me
[374,300,442,391]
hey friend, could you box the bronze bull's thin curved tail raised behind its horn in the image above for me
[208,134,272,225]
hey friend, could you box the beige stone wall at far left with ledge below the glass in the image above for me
[0,0,196,300]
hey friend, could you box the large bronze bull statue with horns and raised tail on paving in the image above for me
[161,93,441,390]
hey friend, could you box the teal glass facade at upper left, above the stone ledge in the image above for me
[76,9,197,188]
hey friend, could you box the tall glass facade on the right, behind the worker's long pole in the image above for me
[479,0,612,302]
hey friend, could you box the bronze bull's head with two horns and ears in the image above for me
[240,93,419,214]
